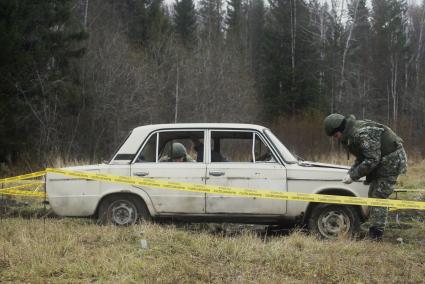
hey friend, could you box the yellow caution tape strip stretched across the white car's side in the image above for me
[46,168,425,210]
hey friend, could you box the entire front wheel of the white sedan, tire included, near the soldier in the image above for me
[308,204,360,239]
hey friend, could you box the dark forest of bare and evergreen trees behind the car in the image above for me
[0,0,425,169]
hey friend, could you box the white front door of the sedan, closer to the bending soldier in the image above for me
[206,130,287,215]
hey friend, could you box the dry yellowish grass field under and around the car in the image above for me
[0,162,425,283]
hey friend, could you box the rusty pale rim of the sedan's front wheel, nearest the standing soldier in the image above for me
[317,210,351,238]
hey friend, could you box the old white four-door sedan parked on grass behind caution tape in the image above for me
[46,123,368,238]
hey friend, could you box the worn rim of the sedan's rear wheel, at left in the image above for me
[109,200,137,226]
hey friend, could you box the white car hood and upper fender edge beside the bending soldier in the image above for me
[287,161,350,181]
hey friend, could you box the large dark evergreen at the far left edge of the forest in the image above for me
[0,0,87,160]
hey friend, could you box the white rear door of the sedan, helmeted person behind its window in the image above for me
[131,130,206,214]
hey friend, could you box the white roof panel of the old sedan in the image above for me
[133,123,265,132]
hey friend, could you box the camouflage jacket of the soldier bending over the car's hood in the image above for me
[341,116,406,180]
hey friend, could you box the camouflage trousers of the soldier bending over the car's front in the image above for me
[369,147,407,230]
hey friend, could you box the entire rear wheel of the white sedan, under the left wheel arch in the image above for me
[98,194,151,226]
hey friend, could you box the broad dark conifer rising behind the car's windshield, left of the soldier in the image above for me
[261,0,319,118]
